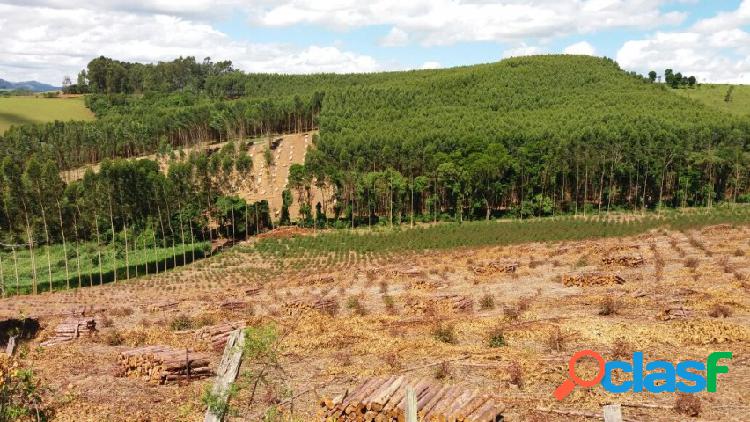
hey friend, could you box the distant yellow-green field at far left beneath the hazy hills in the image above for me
[0,96,94,134]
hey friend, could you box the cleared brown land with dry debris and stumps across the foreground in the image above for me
[0,214,750,420]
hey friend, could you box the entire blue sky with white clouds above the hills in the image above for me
[0,0,750,85]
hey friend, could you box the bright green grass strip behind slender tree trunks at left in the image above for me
[0,239,208,296]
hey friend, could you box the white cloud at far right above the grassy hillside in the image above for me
[617,0,750,83]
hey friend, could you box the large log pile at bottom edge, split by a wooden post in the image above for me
[320,376,504,422]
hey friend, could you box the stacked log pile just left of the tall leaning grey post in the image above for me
[120,346,211,384]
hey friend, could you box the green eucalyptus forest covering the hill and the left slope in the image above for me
[0,56,750,294]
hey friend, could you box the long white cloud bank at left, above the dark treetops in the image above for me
[0,2,381,84]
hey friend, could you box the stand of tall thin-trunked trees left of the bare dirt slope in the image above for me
[0,142,271,292]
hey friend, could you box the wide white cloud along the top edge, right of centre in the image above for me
[250,0,686,45]
